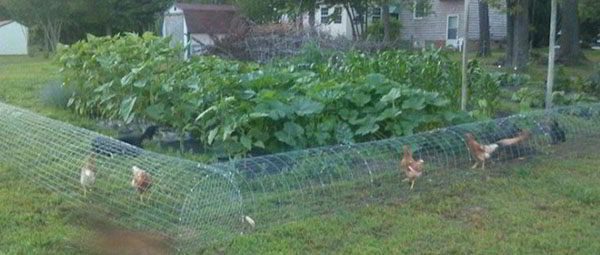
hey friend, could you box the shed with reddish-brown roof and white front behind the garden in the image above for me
[162,3,239,57]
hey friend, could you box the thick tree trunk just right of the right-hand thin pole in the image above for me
[558,0,583,65]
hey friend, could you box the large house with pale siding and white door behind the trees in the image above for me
[290,0,506,47]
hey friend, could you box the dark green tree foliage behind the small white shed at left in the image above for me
[0,0,172,46]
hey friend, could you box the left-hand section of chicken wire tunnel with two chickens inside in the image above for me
[0,100,242,250]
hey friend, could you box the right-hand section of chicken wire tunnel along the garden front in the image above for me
[214,102,600,228]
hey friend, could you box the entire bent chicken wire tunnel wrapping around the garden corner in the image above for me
[0,100,600,250]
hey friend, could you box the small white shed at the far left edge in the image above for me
[0,20,29,55]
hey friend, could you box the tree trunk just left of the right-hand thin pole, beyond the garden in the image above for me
[512,0,530,68]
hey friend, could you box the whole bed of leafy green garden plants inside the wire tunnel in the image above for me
[58,34,507,155]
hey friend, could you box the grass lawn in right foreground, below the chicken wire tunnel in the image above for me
[217,154,600,254]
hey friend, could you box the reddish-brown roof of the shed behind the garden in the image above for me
[175,4,240,34]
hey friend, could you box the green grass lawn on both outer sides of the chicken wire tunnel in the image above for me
[0,55,600,254]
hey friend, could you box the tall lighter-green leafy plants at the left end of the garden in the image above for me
[58,33,180,121]
